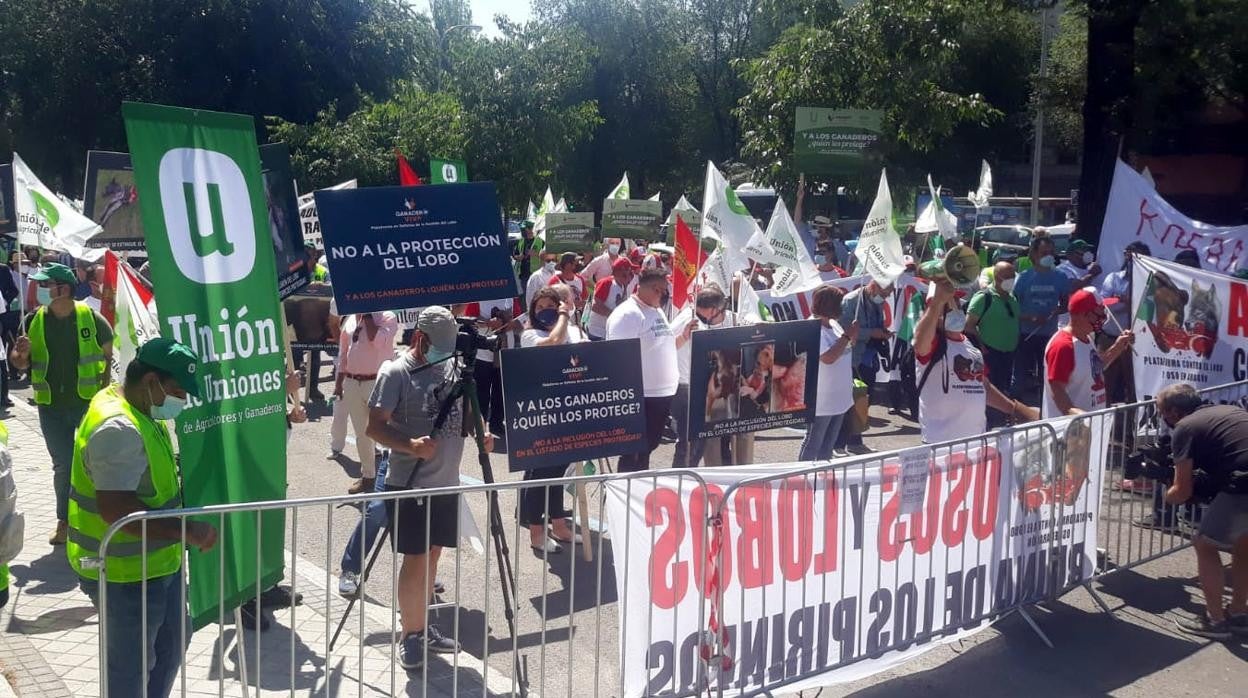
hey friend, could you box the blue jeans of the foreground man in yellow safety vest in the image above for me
[79,572,191,698]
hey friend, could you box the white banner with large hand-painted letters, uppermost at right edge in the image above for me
[1097,160,1248,273]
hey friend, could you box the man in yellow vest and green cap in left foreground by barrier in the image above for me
[65,337,217,697]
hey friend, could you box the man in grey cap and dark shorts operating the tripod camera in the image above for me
[367,306,494,669]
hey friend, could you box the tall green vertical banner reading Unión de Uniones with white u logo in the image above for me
[121,102,286,628]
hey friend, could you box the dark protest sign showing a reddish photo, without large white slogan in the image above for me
[689,320,819,438]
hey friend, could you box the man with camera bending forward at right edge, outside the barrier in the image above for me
[1157,383,1248,639]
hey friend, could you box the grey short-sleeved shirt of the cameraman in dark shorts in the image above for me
[368,352,464,488]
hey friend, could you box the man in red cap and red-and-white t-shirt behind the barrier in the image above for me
[1042,287,1134,420]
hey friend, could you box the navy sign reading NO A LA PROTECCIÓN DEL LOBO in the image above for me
[314,182,518,315]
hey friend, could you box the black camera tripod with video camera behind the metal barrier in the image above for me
[329,347,528,697]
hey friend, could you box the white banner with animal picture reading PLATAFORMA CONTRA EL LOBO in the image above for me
[1131,255,1248,400]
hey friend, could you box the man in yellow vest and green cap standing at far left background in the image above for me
[9,263,112,546]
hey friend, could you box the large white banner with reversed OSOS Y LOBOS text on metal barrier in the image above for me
[607,418,1108,696]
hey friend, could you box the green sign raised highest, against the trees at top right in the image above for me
[792,106,884,175]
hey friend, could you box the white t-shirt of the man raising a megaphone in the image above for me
[915,336,988,443]
